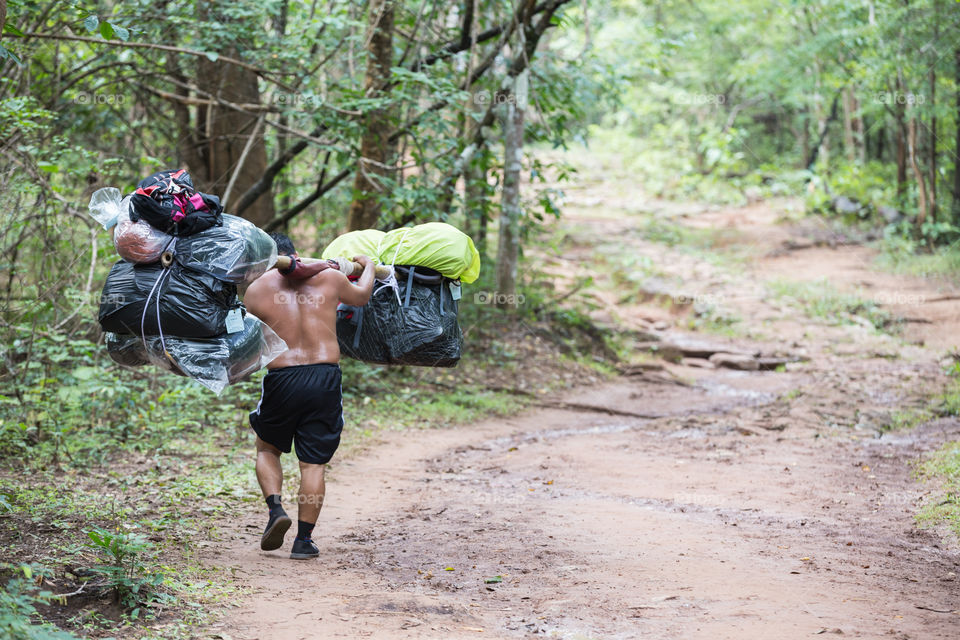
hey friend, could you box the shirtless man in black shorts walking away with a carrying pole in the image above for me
[243,233,374,559]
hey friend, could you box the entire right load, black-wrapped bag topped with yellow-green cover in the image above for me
[322,222,480,367]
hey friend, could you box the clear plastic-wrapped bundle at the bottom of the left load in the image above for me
[106,313,287,394]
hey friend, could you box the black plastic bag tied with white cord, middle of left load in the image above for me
[98,260,241,338]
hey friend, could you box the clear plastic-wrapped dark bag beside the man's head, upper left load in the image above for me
[174,214,277,284]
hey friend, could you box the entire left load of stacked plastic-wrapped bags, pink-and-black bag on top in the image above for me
[90,170,287,393]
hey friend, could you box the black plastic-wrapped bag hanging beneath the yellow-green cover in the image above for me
[337,270,463,367]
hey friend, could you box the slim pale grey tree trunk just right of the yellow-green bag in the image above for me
[495,82,523,308]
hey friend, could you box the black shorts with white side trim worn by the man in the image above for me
[250,364,343,464]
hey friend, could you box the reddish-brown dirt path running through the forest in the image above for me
[211,166,960,640]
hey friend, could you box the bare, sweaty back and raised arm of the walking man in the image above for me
[243,256,374,369]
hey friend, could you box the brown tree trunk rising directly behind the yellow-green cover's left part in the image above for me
[347,0,394,231]
